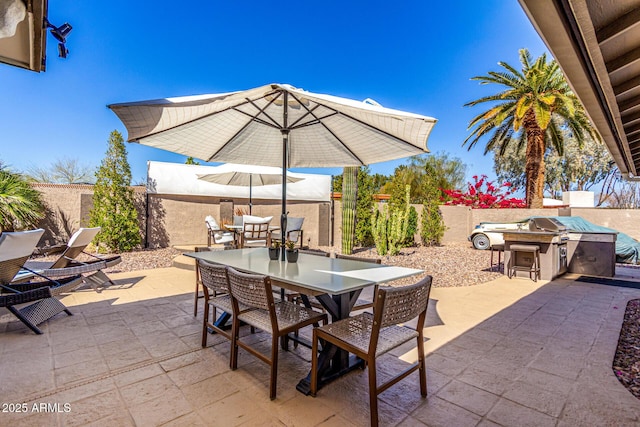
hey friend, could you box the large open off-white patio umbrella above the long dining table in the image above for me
[108,84,436,258]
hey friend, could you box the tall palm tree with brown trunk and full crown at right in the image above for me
[462,49,600,208]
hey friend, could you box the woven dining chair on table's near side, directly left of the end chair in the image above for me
[227,267,327,400]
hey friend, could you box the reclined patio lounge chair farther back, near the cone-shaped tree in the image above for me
[25,227,122,290]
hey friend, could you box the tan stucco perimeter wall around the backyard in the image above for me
[34,184,640,251]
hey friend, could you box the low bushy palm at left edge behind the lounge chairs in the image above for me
[0,169,45,231]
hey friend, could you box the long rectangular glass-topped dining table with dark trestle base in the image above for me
[185,248,423,394]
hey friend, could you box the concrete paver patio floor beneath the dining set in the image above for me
[0,268,640,426]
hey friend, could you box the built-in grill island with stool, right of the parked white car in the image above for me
[503,217,617,280]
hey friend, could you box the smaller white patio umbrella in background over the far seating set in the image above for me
[197,163,304,215]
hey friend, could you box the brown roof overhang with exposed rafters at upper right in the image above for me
[519,0,640,178]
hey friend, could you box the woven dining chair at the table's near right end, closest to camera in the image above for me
[311,276,432,426]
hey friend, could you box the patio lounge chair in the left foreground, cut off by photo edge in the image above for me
[0,229,82,334]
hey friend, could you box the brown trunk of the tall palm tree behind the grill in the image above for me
[523,110,545,209]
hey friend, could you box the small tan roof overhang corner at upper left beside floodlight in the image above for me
[0,0,48,72]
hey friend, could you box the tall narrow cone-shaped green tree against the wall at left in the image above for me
[90,130,140,252]
